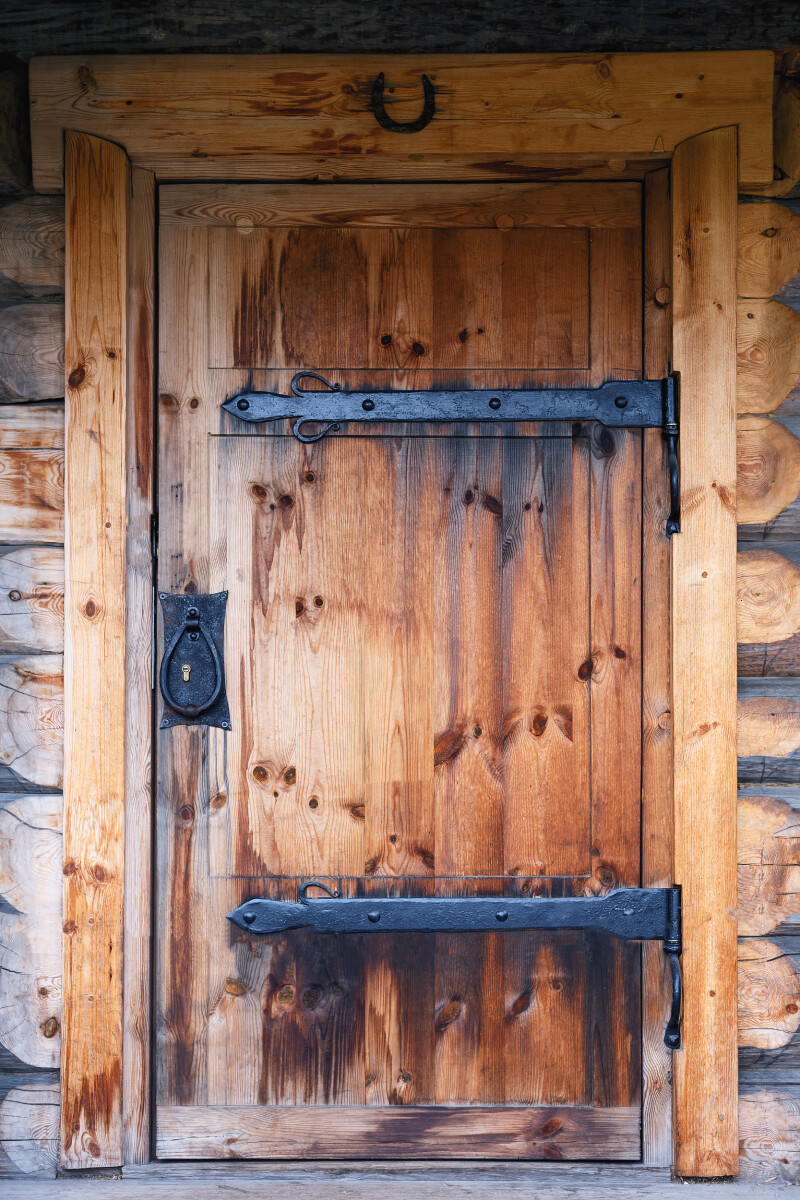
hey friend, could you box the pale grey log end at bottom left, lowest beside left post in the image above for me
[0,1074,61,1187]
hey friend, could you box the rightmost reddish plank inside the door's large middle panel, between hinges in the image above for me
[503,438,591,876]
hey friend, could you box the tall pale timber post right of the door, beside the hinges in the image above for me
[672,127,739,1176]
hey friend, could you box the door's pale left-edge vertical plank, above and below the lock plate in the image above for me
[156,228,212,1104]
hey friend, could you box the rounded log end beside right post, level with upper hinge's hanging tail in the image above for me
[736,416,800,526]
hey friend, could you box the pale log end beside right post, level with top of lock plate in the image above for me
[736,550,800,644]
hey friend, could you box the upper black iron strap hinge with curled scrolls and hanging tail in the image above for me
[222,371,680,536]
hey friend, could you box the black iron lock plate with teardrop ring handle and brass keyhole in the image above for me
[158,592,230,730]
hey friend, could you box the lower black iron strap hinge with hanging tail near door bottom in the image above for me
[228,880,681,1049]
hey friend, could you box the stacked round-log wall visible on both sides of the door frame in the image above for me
[0,28,800,1182]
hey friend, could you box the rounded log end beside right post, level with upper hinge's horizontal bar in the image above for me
[736,300,800,413]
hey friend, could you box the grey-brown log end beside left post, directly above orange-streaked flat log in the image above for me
[0,301,64,401]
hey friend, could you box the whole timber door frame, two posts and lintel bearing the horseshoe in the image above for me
[42,52,774,1176]
